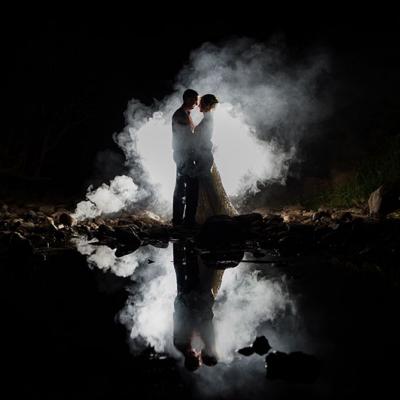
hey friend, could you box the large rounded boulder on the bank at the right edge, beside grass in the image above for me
[368,184,400,218]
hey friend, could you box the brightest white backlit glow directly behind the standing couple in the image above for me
[128,103,292,209]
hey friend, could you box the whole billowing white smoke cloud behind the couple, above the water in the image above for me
[76,39,327,218]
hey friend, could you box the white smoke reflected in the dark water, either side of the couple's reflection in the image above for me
[77,239,294,363]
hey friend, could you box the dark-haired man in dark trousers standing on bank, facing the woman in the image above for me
[172,89,199,227]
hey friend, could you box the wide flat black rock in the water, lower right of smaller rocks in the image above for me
[265,351,321,383]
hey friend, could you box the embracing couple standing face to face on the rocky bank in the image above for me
[172,89,237,227]
